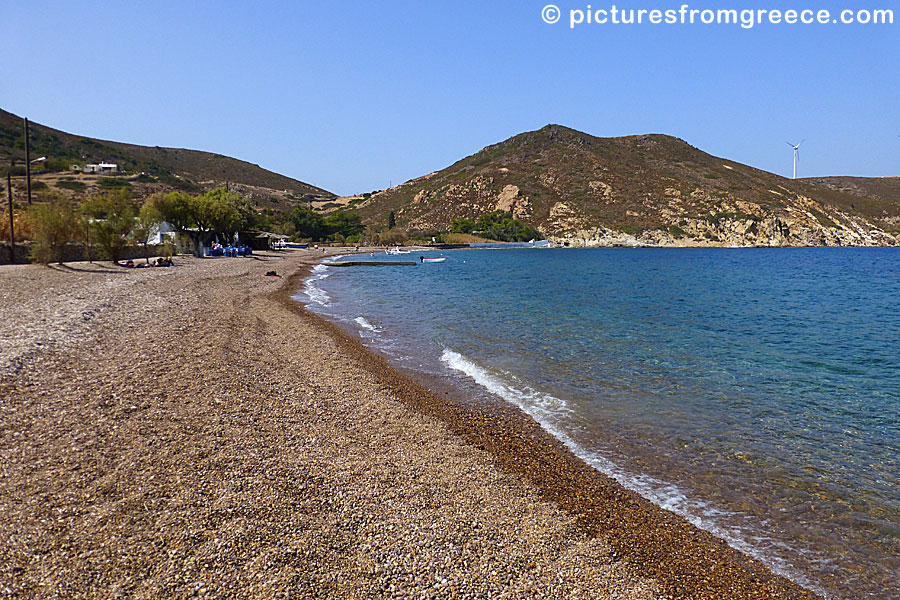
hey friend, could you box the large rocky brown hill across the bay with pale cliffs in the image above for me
[357,125,900,246]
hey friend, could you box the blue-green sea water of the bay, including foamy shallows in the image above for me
[301,248,900,598]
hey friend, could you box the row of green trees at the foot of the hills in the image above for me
[8,188,540,263]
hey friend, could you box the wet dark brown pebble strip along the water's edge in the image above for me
[284,253,820,599]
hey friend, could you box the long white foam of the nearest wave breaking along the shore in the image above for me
[441,348,827,597]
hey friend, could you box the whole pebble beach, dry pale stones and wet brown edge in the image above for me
[0,250,814,600]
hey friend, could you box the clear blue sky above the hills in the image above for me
[0,0,900,194]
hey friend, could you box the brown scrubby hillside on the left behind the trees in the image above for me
[0,110,335,201]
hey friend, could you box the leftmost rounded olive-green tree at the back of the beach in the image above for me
[25,191,82,264]
